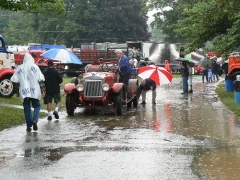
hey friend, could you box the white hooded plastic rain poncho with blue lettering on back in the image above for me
[11,53,45,101]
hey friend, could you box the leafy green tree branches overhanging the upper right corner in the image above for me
[144,0,240,55]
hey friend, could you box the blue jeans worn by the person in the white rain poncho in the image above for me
[23,97,40,127]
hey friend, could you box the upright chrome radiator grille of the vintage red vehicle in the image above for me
[84,80,103,98]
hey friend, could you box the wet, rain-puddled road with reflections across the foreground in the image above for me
[0,77,240,180]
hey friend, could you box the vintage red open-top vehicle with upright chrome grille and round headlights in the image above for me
[64,60,138,115]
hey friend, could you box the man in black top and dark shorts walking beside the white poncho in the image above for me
[44,60,63,120]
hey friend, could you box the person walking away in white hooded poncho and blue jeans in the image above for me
[11,53,45,132]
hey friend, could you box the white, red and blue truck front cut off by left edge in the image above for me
[0,35,15,97]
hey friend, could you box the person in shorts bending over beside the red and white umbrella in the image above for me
[137,78,157,104]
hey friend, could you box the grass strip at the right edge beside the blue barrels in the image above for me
[215,83,240,117]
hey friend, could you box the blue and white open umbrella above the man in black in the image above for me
[41,49,82,64]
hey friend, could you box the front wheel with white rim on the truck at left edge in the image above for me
[0,75,14,97]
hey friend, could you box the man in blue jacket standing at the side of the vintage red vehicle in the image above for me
[115,50,132,99]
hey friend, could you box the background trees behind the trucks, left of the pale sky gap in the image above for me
[0,0,150,47]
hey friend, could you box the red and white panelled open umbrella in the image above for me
[138,65,172,86]
